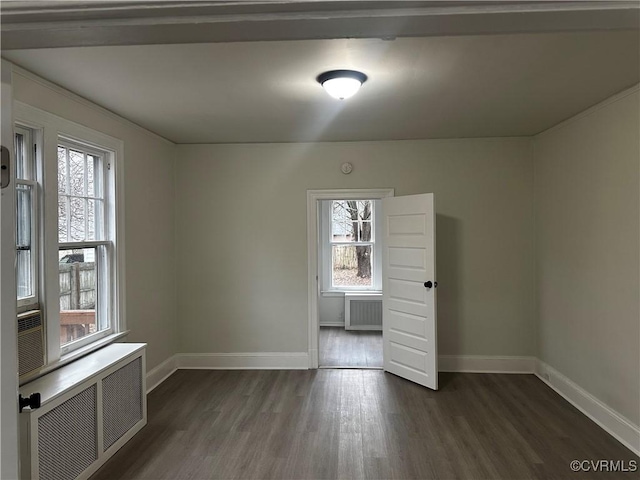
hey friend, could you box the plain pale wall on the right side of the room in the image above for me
[534,88,640,425]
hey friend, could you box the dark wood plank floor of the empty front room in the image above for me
[92,369,638,480]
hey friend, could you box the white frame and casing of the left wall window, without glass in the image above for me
[14,101,127,368]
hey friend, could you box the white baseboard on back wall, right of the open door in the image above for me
[438,355,536,373]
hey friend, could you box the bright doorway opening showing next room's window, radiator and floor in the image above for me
[318,198,383,368]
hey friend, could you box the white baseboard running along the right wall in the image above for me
[535,360,640,456]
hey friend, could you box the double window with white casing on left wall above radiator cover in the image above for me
[15,102,125,372]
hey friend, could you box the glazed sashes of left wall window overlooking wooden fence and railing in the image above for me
[57,139,112,347]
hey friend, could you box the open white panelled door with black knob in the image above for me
[382,193,438,390]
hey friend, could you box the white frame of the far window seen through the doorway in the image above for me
[319,198,382,297]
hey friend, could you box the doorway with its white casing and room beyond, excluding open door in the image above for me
[307,189,393,369]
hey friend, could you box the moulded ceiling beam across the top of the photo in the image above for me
[0,0,640,50]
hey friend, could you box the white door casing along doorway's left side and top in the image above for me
[307,188,395,369]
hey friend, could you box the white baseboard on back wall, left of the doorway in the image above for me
[176,352,309,370]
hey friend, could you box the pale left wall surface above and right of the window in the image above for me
[14,73,177,369]
